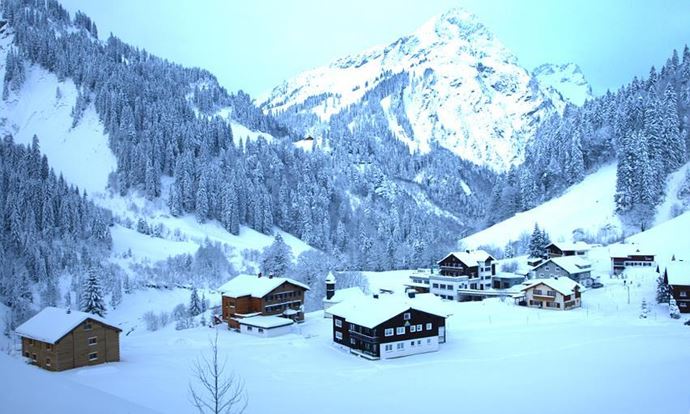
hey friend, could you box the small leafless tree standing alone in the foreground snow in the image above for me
[189,332,248,414]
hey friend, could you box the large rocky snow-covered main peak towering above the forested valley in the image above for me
[261,9,564,171]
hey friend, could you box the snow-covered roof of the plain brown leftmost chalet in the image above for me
[15,306,122,344]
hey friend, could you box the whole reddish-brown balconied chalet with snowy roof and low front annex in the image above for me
[218,273,309,336]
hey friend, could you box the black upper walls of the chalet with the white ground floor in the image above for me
[333,309,446,358]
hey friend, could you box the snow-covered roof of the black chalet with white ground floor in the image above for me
[328,294,448,328]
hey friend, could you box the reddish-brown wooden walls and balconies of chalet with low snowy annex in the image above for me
[222,281,306,329]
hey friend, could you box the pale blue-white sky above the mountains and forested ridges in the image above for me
[62,0,690,96]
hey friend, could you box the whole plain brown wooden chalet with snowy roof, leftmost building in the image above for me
[15,307,122,371]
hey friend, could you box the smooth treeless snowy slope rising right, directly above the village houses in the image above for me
[461,164,622,247]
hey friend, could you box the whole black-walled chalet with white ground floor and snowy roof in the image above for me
[329,293,447,359]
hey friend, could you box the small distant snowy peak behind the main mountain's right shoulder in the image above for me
[532,63,593,106]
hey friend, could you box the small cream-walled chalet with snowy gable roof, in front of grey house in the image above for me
[522,277,583,310]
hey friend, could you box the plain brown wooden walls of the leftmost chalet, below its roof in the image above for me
[21,319,122,371]
